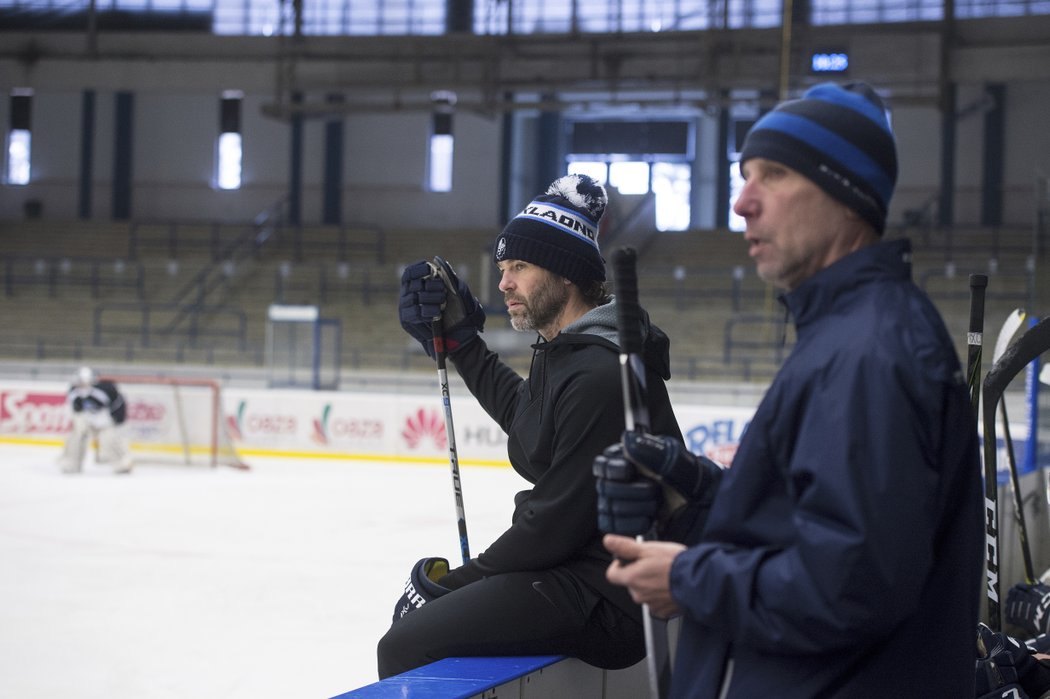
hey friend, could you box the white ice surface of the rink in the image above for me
[0,445,528,699]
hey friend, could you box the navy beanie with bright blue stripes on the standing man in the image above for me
[740,82,897,233]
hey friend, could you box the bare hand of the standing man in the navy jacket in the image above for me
[602,534,686,618]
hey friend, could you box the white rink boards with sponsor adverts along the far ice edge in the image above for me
[0,381,752,466]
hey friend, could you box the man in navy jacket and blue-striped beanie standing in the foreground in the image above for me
[605,83,984,699]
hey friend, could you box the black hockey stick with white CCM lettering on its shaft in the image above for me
[983,318,1050,631]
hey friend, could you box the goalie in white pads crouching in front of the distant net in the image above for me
[59,366,132,473]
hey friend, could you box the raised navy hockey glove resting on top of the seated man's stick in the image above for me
[399,252,485,359]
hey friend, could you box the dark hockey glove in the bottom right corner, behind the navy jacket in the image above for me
[974,623,1050,699]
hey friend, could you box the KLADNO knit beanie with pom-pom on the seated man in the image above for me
[492,174,609,287]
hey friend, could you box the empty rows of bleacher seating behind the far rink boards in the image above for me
[0,220,1050,381]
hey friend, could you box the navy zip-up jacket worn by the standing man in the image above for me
[671,240,984,699]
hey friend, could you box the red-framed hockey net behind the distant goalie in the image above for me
[102,375,248,469]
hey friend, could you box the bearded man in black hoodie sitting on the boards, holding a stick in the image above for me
[378,175,680,678]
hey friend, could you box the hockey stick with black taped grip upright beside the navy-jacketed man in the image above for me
[612,248,671,699]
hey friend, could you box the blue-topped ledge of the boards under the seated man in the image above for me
[332,655,648,699]
